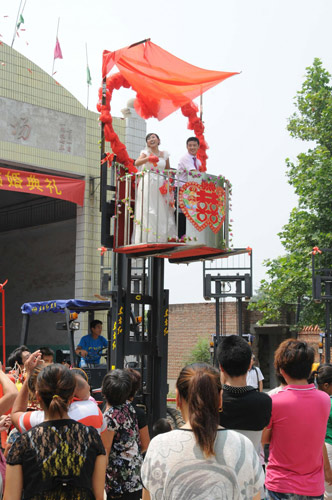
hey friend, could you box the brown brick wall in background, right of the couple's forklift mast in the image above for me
[168,302,260,381]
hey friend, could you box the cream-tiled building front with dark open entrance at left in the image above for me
[0,44,146,351]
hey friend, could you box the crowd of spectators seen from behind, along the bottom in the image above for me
[0,335,332,500]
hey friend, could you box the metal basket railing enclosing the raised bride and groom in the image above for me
[113,169,230,248]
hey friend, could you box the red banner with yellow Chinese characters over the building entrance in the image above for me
[0,167,85,206]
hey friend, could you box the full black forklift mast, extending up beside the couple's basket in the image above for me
[100,160,169,427]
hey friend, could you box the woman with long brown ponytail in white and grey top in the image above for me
[142,363,264,500]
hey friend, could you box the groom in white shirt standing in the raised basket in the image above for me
[176,137,201,238]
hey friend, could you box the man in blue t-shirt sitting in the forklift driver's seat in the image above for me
[75,319,107,366]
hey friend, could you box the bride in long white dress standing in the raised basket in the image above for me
[132,133,177,245]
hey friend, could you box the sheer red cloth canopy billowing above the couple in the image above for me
[103,41,238,120]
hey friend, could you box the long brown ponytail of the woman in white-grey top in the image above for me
[176,363,221,457]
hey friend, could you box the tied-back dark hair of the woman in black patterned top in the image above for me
[36,363,76,416]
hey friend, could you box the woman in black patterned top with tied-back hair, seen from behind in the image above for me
[4,358,106,500]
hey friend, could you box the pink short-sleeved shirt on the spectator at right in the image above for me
[265,384,331,496]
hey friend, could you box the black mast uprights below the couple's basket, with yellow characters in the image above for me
[108,254,169,428]
